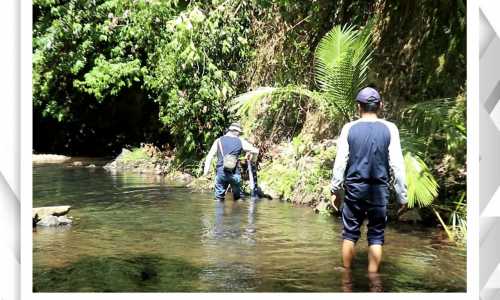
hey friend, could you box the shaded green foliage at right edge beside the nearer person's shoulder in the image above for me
[399,94,466,213]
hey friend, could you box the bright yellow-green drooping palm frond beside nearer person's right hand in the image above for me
[404,152,439,207]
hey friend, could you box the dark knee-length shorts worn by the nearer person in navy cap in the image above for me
[342,201,387,245]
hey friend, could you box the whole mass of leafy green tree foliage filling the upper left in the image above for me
[33,0,252,157]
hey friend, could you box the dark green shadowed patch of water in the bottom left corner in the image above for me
[33,255,200,292]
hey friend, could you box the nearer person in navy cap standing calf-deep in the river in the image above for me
[331,87,407,273]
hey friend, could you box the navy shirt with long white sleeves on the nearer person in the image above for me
[332,118,406,206]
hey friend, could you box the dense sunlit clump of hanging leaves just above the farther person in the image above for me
[146,1,254,154]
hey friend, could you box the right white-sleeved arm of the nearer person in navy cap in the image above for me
[389,124,408,204]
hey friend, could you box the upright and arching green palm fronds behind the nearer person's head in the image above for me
[232,23,373,131]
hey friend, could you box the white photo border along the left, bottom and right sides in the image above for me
[20,0,479,300]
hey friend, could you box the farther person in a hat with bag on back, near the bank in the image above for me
[203,123,259,201]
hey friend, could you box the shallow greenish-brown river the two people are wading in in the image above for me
[33,161,466,292]
